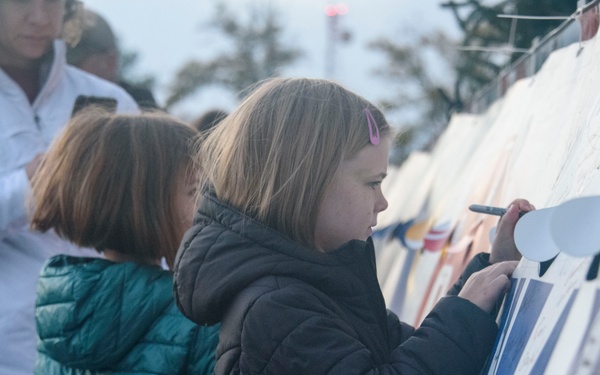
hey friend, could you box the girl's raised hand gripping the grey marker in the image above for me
[490,199,535,264]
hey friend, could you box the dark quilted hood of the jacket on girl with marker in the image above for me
[174,194,375,324]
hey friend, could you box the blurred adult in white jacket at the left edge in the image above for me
[0,0,138,375]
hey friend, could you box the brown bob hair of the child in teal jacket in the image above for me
[31,108,198,267]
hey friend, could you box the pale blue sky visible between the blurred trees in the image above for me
[83,0,459,120]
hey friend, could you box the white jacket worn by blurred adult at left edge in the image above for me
[0,41,138,375]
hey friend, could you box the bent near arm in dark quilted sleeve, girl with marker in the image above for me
[239,291,498,375]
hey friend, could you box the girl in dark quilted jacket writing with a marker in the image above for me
[174,78,526,375]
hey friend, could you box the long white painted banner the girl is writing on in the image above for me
[374,22,600,375]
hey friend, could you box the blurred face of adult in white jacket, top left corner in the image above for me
[0,0,65,68]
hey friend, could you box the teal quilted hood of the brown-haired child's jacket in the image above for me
[36,255,173,369]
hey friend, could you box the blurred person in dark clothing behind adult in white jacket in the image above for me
[67,9,158,108]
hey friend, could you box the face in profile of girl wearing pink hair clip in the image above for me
[315,138,391,251]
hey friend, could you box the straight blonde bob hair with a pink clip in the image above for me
[197,78,391,251]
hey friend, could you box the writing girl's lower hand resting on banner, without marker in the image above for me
[458,261,519,313]
